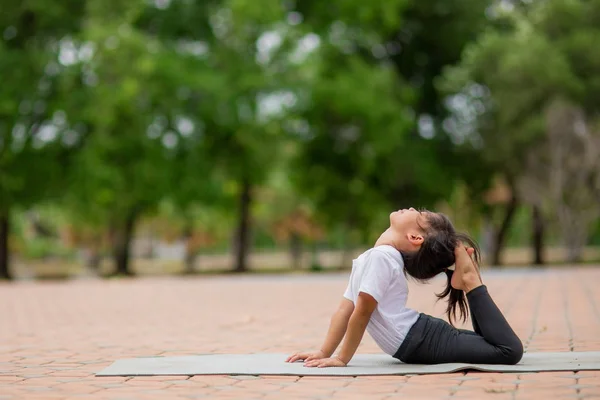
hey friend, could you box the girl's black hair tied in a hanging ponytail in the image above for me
[401,212,481,325]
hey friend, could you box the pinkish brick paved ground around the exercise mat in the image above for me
[0,268,600,400]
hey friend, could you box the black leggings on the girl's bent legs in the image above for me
[394,285,523,364]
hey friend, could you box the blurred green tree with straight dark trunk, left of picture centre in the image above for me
[138,0,290,271]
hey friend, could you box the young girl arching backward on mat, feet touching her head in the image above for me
[286,208,523,367]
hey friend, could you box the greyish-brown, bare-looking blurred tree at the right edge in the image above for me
[523,99,600,262]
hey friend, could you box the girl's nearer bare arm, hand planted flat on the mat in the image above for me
[306,292,377,367]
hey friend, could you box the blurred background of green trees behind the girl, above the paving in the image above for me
[0,0,600,279]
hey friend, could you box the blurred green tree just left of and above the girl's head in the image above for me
[288,1,410,250]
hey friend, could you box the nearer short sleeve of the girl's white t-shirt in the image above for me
[358,251,396,303]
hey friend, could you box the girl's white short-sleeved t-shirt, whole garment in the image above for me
[344,245,419,356]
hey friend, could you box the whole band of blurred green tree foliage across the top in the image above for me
[0,0,600,276]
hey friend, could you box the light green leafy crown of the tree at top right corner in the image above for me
[440,0,600,175]
